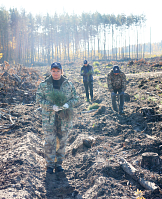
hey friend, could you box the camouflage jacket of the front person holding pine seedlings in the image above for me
[36,76,78,130]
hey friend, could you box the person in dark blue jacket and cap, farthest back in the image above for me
[81,60,93,102]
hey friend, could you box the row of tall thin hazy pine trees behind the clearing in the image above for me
[0,8,146,65]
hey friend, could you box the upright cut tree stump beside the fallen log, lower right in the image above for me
[141,152,160,169]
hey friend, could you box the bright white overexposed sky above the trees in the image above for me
[0,0,162,42]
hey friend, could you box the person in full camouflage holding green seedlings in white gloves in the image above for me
[36,62,78,174]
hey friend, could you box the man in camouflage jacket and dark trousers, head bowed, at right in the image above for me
[107,65,126,114]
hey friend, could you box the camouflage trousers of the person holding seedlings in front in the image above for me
[42,111,68,168]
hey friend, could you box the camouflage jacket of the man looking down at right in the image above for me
[107,70,126,92]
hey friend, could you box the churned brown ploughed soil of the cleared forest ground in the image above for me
[0,58,162,199]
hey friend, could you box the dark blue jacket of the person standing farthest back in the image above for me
[81,64,93,82]
